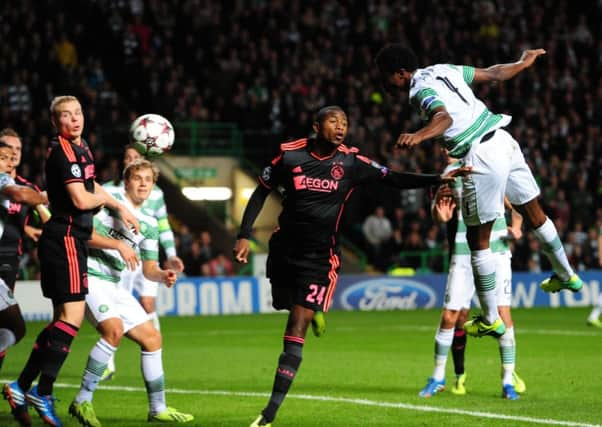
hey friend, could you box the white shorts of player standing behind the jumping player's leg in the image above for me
[443,253,512,311]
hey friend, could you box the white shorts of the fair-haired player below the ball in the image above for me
[86,276,148,332]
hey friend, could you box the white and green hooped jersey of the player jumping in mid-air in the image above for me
[410,64,512,159]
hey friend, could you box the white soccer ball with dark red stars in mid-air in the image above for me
[130,114,175,157]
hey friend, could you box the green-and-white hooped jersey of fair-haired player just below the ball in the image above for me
[88,188,159,283]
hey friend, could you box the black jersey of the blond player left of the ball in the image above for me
[44,136,96,239]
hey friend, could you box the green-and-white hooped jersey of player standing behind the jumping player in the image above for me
[443,162,510,257]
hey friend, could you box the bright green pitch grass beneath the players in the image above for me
[0,308,602,426]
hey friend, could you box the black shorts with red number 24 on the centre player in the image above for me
[266,233,340,312]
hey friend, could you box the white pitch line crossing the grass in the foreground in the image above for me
[45,383,602,427]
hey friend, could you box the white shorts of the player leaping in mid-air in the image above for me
[462,129,540,225]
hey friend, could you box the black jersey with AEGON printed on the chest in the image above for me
[259,139,389,256]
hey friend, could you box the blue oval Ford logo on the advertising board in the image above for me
[341,278,437,311]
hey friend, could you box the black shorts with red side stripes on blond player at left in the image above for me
[38,232,88,305]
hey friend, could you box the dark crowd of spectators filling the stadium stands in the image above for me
[0,0,602,274]
